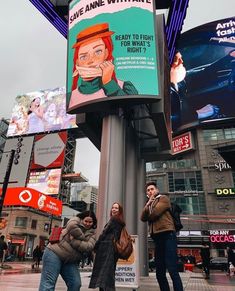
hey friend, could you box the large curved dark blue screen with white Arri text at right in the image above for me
[171,17,235,130]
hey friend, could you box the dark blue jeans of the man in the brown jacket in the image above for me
[153,231,183,291]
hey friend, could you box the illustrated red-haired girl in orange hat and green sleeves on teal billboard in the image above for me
[69,23,138,109]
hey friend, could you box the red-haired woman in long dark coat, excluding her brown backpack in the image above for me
[89,202,125,291]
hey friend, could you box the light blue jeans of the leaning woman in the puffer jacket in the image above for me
[39,248,81,291]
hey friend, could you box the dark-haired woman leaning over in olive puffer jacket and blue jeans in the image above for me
[39,211,97,291]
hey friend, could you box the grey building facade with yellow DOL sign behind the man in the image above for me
[146,126,235,257]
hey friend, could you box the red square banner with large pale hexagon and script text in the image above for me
[31,131,67,170]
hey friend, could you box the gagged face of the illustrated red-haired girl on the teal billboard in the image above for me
[76,38,108,80]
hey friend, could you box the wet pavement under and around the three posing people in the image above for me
[0,262,235,291]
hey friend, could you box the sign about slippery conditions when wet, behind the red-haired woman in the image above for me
[115,235,140,289]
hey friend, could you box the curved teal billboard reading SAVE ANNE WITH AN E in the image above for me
[67,0,159,113]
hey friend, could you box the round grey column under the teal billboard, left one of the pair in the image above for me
[97,115,125,233]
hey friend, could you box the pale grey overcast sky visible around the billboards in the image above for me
[0,0,235,185]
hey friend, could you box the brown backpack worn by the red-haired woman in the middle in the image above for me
[114,227,133,260]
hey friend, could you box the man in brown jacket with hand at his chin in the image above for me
[141,181,183,291]
